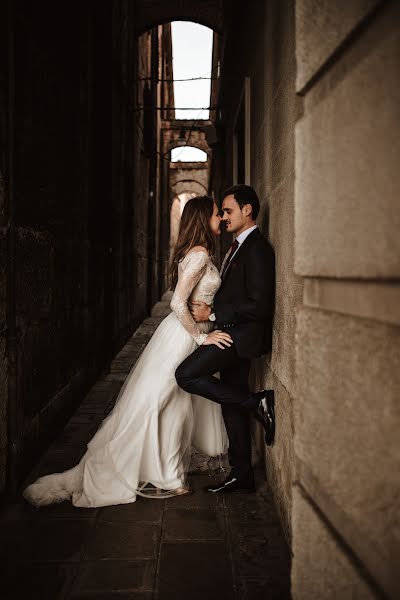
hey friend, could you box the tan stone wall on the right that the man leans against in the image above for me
[211,0,400,600]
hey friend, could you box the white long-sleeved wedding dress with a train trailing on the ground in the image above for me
[24,250,227,507]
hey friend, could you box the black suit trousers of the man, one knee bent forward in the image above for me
[175,345,253,482]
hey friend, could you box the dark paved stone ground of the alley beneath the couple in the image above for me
[0,296,290,600]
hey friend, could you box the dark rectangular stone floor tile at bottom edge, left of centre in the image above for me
[73,560,156,594]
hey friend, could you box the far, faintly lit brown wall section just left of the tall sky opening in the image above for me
[132,25,174,316]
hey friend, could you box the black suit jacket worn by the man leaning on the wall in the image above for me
[214,229,275,358]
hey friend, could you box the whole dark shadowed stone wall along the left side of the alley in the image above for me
[0,0,171,491]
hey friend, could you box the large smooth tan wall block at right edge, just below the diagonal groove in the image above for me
[295,12,400,278]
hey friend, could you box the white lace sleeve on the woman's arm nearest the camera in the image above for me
[170,250,209,346]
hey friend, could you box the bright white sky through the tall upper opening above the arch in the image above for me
[171,21,213,119]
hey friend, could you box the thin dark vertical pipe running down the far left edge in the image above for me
[6,0,18,496]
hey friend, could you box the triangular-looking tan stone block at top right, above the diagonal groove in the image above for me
[296,0,379,91]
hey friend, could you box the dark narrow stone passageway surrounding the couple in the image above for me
[0,0,400,600]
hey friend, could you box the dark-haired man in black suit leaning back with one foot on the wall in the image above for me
[175,185,275,494]
